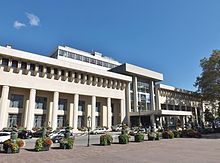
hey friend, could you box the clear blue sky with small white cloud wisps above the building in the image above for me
[0,0,220,90]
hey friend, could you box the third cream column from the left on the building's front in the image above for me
[52,92,59,130]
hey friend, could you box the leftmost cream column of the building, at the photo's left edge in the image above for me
[0,86,9,130]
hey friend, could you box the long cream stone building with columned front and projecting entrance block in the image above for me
[0,46,202,131]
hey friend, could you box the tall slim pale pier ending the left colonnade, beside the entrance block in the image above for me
[126,83,131,126]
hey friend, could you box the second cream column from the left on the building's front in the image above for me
[27,89,36,130]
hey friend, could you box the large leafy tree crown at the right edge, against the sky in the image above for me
[195,50,220,103]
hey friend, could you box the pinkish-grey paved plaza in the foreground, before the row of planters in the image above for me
[0,137,220,163]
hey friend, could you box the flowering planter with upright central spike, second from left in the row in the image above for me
[35,128,53,152]
